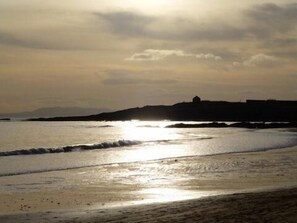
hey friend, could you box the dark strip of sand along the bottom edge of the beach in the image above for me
[0,187,297,223]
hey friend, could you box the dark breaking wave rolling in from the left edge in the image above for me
[0,140,143,157]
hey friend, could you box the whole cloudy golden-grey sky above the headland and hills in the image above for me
[0,0,297,113]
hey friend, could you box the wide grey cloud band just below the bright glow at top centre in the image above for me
[94,12,244,40]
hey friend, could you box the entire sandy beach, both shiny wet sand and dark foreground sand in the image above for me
[0,147,297,223]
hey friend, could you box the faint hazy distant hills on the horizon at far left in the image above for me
[0,107,111,118]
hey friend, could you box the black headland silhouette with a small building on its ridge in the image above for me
[30,96,297,122]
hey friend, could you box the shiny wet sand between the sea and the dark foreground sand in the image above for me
[0,146,297,223]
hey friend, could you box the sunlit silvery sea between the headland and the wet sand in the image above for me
[0,120,297,177]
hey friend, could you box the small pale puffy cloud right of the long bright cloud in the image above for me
[233,53,278,67]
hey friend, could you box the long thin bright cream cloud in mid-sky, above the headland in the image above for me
[125,49,222,61]
